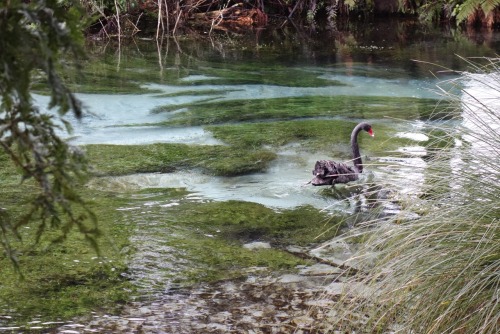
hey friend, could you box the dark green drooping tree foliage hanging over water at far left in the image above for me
[0,0,99,266]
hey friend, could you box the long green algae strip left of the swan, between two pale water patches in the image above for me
[85,144,276,176]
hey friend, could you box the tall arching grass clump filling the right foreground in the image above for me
[326,58,500,334]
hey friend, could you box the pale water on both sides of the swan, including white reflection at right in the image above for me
[94,152,425,212]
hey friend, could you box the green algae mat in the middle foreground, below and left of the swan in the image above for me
[141,201,341,284]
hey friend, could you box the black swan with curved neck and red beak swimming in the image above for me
[310,123,375,186]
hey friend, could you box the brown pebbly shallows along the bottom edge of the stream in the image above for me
[0,242,369,334]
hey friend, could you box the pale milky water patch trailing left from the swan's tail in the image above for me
[94,156,336,209]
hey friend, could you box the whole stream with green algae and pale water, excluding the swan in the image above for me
[0,22,495,333]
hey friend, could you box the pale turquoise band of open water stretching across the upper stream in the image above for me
[34,67,442,144]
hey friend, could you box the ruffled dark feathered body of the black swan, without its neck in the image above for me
[311,160,358,186]
